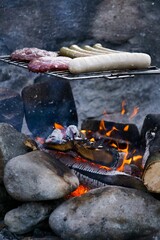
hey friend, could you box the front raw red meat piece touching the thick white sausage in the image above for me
[28,56,72,72]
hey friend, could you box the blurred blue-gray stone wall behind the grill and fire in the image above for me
[0,0,160,133]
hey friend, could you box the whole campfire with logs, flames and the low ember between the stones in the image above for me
[40,117,143,196]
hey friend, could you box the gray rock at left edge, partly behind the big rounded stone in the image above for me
[0,123,28,181]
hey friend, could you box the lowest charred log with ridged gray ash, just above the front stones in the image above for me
[49,150,146,191]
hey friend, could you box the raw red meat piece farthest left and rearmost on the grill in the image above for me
[10,48,58,62]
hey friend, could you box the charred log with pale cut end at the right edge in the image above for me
[141,114,160,193]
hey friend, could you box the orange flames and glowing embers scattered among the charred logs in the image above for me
[45,119,142,179]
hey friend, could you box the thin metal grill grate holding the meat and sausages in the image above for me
[0,55,160,80]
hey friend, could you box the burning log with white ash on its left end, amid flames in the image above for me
[45,125,119,167]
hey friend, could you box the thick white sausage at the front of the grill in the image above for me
[69,52,151,74]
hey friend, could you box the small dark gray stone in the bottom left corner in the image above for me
[4,202,56,234]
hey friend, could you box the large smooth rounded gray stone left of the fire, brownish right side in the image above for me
[4,150,79,201]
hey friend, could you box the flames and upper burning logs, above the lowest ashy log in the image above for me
[41,101,144,182]
